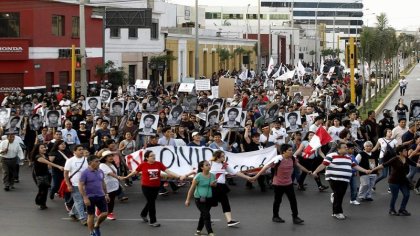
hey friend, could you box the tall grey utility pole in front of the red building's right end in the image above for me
[79,0,88,97]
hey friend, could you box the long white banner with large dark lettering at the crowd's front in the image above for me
[125,146,277,175]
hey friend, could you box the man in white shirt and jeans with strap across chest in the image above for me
[64,144,88,225]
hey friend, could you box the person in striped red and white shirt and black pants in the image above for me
[312,143,370,220]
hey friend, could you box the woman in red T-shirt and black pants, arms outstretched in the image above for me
[124,150,185,227]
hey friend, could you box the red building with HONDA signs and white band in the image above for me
[0,0,103,96]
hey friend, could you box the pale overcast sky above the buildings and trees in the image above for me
[167,0,420,30]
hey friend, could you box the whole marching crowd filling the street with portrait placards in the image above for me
[0,61,420,236]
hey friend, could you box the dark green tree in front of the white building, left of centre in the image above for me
[95,60,128,90]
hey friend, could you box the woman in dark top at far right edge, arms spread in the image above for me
[372,146,420,216]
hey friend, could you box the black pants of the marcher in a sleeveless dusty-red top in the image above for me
[273,184,298,217]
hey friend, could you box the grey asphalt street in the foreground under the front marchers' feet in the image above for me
[0,164,420,236]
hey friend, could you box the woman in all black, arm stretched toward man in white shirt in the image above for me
[31,144,64,210]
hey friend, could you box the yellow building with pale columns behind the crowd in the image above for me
[165,28,257,83]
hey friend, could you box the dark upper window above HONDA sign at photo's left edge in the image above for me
[0,12,20,38]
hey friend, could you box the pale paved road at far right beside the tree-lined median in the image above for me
[377,64,420,123]
